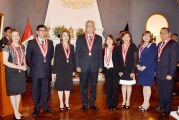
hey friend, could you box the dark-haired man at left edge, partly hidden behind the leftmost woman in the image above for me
[0,27,12,51]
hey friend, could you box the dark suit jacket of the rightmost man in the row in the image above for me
[157,40,178,80]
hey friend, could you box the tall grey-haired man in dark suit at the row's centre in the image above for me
[75,20,102,112]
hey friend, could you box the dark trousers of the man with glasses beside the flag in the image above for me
[32,78,51,111]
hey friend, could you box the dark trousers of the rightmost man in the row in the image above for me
[157,78,174,113]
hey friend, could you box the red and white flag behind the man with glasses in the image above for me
[21,20,34,47]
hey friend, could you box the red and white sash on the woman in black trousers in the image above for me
[104,46,114,66]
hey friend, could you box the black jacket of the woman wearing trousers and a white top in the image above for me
[103,46,122,75]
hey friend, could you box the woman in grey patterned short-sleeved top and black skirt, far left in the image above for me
[3,29,27,120]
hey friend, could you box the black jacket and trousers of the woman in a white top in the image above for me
[103,46,120,106]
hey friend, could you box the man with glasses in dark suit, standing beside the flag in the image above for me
[26,25,54,116]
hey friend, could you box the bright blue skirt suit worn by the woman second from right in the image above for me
[138,43,157,86]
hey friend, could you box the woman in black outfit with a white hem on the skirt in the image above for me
[119,32,137,108]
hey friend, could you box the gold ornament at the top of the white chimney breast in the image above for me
[62,0,94,9]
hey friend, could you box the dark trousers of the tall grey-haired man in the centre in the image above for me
[80,69,98,107]
